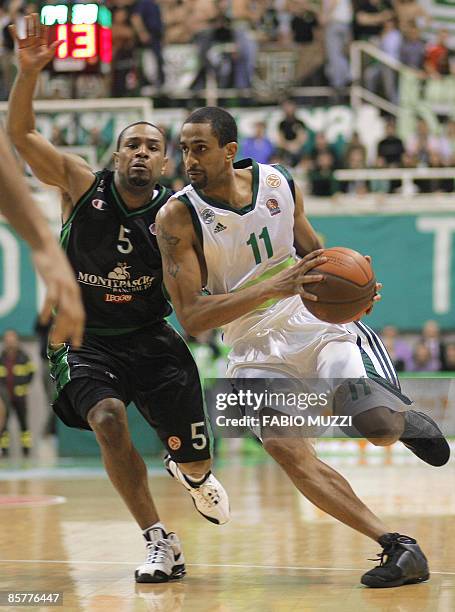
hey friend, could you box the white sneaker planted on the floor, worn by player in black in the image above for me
[134,527,185,582]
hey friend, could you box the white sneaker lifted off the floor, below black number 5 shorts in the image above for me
[164,455,230,525]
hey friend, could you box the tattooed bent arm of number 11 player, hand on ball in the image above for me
[156,199,326,336]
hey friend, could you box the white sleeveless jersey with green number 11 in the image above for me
[176,160,312,346]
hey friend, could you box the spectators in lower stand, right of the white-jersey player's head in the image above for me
[240,100,455,197]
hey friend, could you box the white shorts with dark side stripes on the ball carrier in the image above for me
[227,306,412,432]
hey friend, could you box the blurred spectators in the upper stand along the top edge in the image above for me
[0,0,453,101]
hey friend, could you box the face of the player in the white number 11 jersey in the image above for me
[180,123,237,189]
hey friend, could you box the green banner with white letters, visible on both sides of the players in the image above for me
[0,213,455,335]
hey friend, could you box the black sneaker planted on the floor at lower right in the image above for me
[360,533,430,589]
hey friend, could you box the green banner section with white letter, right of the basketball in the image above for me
[311,214,455,331]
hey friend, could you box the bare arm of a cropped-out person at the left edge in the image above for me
[0,125,84,347]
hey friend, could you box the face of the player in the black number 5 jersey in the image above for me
[115,124,167,189]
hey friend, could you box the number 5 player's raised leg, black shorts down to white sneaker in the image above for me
[131,324,230,525]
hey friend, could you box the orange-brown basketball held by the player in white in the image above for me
[302,247,376,323]
